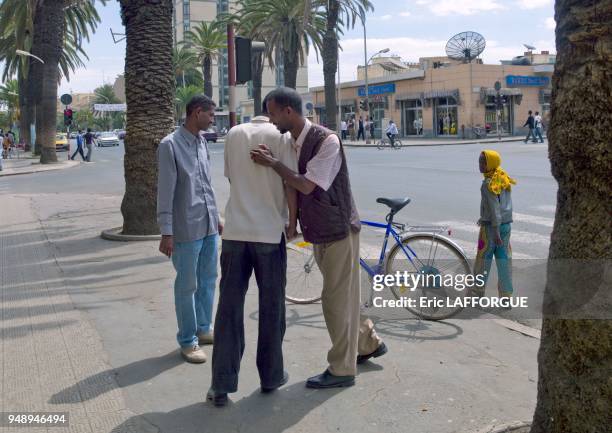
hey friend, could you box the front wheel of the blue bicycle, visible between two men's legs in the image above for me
[285,239,323,304]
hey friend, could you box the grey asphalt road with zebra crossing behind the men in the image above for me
[0,137,557,259]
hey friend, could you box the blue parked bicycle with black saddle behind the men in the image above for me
[285,197,471,320]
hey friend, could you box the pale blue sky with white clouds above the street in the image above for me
[59,0,556,94]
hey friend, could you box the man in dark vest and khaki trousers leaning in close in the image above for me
[251,87,387,388]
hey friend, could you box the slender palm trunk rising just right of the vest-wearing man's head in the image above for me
[323,0,340,131]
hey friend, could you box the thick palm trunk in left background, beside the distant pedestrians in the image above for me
[34,0,65,164]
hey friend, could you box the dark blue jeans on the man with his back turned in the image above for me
[212,236,287,393]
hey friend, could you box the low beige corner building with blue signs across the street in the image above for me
[311,59,554,138]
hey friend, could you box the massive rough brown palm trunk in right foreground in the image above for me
[531,0,612,433]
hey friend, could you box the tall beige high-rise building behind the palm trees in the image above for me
[173,0,308,129]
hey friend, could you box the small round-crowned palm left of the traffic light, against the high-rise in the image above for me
[187,21,227,98]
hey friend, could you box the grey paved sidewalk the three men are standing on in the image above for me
[0,193,539,433]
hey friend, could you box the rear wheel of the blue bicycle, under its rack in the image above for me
[385,233,472,320]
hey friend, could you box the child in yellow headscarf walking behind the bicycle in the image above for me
[474,150,516,297]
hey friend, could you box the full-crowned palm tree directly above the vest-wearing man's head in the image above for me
[240,0,325,89]
